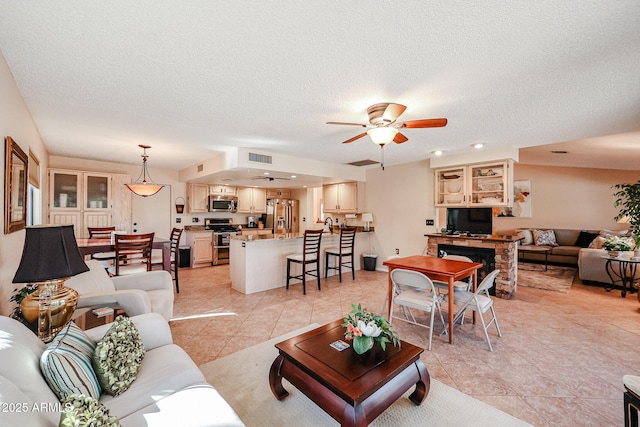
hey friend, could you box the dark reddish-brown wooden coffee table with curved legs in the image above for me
[269,320,430,426]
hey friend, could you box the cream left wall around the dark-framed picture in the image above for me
[0,54,48,315]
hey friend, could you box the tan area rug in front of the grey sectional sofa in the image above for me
[518,263,578,294]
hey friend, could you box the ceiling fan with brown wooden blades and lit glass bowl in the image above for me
[327,102,447,170]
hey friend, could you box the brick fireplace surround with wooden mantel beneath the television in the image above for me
[425,234,520,299]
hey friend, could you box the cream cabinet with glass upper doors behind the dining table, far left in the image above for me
[48,169,131,237]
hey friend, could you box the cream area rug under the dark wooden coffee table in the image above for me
[200,325,529,427]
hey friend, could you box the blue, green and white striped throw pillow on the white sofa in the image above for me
[40,322,102,399]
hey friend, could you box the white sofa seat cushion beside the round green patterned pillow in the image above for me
[100,344,206,420]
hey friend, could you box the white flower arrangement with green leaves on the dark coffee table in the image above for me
[342,304,400,354]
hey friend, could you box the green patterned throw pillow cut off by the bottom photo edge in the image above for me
[59,394,120,427]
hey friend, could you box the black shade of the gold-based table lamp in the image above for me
[13,225,89,283]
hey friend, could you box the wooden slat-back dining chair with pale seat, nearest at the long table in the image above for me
[109,233,155,276]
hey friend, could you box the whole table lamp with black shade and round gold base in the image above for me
[13,225,89,342]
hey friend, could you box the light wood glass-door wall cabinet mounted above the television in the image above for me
[435,160,513,206]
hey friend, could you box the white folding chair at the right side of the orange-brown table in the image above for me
[445,270,502,351]
